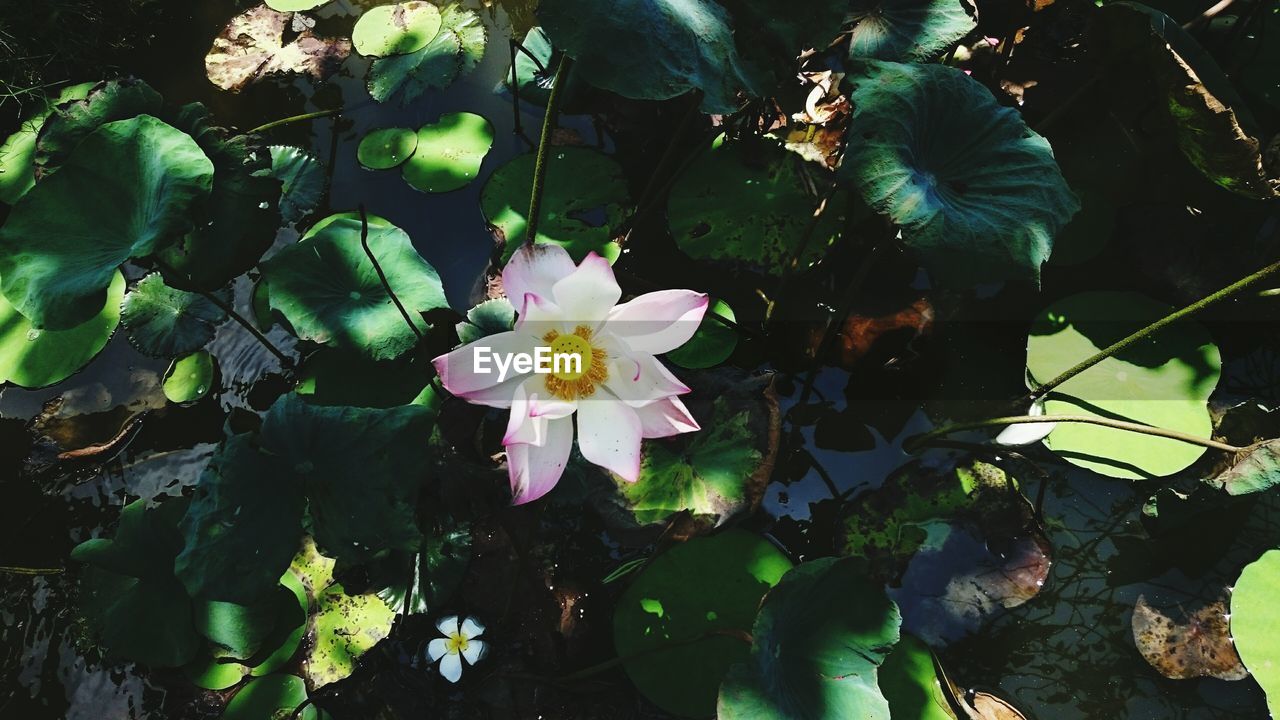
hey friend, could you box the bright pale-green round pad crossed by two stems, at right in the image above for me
[1027,292,1222,479]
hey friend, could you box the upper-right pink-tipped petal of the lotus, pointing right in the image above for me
[604,290,708,355]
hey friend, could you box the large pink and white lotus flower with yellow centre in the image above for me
[433,245,707,505]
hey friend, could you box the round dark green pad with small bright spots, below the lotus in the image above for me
[613,529,791,717]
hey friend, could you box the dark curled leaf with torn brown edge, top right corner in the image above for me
[1094,1,1280,200]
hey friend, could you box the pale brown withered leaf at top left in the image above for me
[205,5,351,92]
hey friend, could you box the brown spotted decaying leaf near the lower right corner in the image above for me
[1133,596,1249,680]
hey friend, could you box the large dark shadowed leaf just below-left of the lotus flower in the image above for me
[260,392,433,562]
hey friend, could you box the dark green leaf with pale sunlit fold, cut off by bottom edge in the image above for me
[716,557,901,720]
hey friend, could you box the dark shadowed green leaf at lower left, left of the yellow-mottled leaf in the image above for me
[72,500,200,667]
